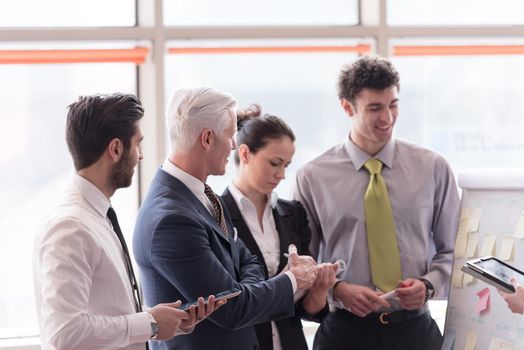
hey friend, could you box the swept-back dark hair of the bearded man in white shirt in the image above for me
[66,93,144,170]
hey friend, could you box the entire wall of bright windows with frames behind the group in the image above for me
[0,0,524,349]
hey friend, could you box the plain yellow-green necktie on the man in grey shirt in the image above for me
[364,158,402,292]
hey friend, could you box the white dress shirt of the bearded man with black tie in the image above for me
[33,175,151,350]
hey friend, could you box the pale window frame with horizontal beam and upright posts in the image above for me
[0,0,524,350]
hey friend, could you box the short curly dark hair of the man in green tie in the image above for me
[338,55,400,103]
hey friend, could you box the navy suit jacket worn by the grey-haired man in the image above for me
[133,169,295,350]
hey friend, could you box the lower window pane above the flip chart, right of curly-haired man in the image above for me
[393,40,524,172]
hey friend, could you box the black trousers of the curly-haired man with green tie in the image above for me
[313,309,442,350]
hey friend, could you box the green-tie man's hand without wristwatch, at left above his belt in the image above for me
[333,282,391,317]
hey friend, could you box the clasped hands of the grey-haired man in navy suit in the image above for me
[288,244,339,290]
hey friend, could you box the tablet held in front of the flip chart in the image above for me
[461,256,524,293]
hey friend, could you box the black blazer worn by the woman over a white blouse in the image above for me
[222,189,329,350]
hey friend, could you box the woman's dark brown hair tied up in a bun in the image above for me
[235,104,295,165]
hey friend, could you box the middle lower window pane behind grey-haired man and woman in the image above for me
[166,40,370,198]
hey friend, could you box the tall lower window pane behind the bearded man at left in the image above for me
[0,43,138,338]
